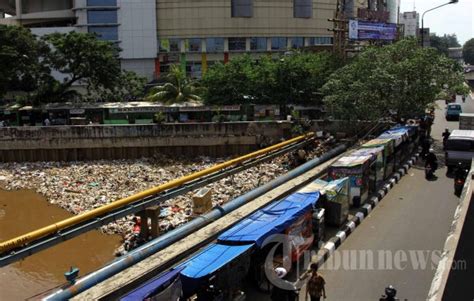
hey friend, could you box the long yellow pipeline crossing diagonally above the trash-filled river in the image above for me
[0,133,314,254]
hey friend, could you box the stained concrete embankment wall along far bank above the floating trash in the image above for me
[0,121,382,162]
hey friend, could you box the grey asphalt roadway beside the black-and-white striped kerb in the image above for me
[318,96,474,301]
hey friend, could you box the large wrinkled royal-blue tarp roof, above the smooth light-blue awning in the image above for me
[218,190,319,247]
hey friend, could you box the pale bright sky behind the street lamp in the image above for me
[400,0,474,46]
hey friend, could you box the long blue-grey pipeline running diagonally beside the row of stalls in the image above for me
[43,145,347,300]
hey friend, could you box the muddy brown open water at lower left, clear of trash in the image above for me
[0,189,121,300]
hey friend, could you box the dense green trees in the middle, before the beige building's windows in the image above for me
[202,53,341,104]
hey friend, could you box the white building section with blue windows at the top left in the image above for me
[0,0,158,79]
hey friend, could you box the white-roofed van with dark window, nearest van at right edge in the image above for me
[446,130,474,170]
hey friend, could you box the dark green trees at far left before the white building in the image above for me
[0,25,146,105]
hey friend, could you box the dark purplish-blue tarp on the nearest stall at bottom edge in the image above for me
[120,266,184,301]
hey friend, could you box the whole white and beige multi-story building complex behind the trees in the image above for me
[0,0,398,79]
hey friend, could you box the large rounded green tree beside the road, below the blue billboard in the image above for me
[322,39,463,120]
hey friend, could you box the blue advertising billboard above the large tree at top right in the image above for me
[349,20,397,41]
